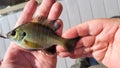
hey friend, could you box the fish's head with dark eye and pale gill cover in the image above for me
[7,29,26,43]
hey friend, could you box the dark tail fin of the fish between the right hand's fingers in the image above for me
[65,37,80,53]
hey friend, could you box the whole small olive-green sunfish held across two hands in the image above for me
[1,16,80,54]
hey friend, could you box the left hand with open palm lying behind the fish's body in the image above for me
[1,0,62,68]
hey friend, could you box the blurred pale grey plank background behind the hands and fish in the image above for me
[0,0,120,68]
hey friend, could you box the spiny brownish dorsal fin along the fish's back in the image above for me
[31,16,59,31]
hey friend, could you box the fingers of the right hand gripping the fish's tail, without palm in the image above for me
[57,20,102,58]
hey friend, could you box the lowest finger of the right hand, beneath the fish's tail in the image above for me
[58,47,92,58]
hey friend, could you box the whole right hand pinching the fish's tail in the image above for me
[57,18,120,68]
